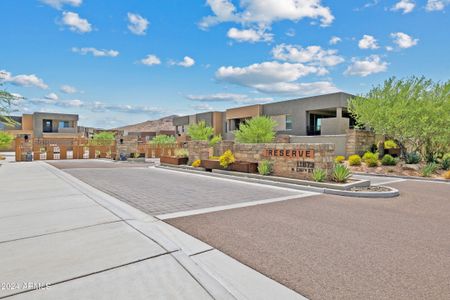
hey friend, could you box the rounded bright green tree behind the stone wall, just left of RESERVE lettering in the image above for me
[235,116,277,143]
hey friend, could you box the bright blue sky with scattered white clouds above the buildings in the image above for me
[0,0,450,128]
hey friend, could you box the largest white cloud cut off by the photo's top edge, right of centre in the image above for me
[199,0,334,28]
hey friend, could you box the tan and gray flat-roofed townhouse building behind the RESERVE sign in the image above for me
[174,92,355,140]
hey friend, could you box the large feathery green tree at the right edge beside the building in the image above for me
[348,77,450,160]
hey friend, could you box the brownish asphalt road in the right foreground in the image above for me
[167,181,450,299]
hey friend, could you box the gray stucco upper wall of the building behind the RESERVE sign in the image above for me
[263,92,353,135]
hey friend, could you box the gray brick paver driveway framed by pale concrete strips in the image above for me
[64,168,302,215]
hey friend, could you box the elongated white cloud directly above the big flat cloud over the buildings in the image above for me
[272,44,344,67]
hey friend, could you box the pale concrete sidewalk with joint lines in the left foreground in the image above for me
[0,162,304,299]
